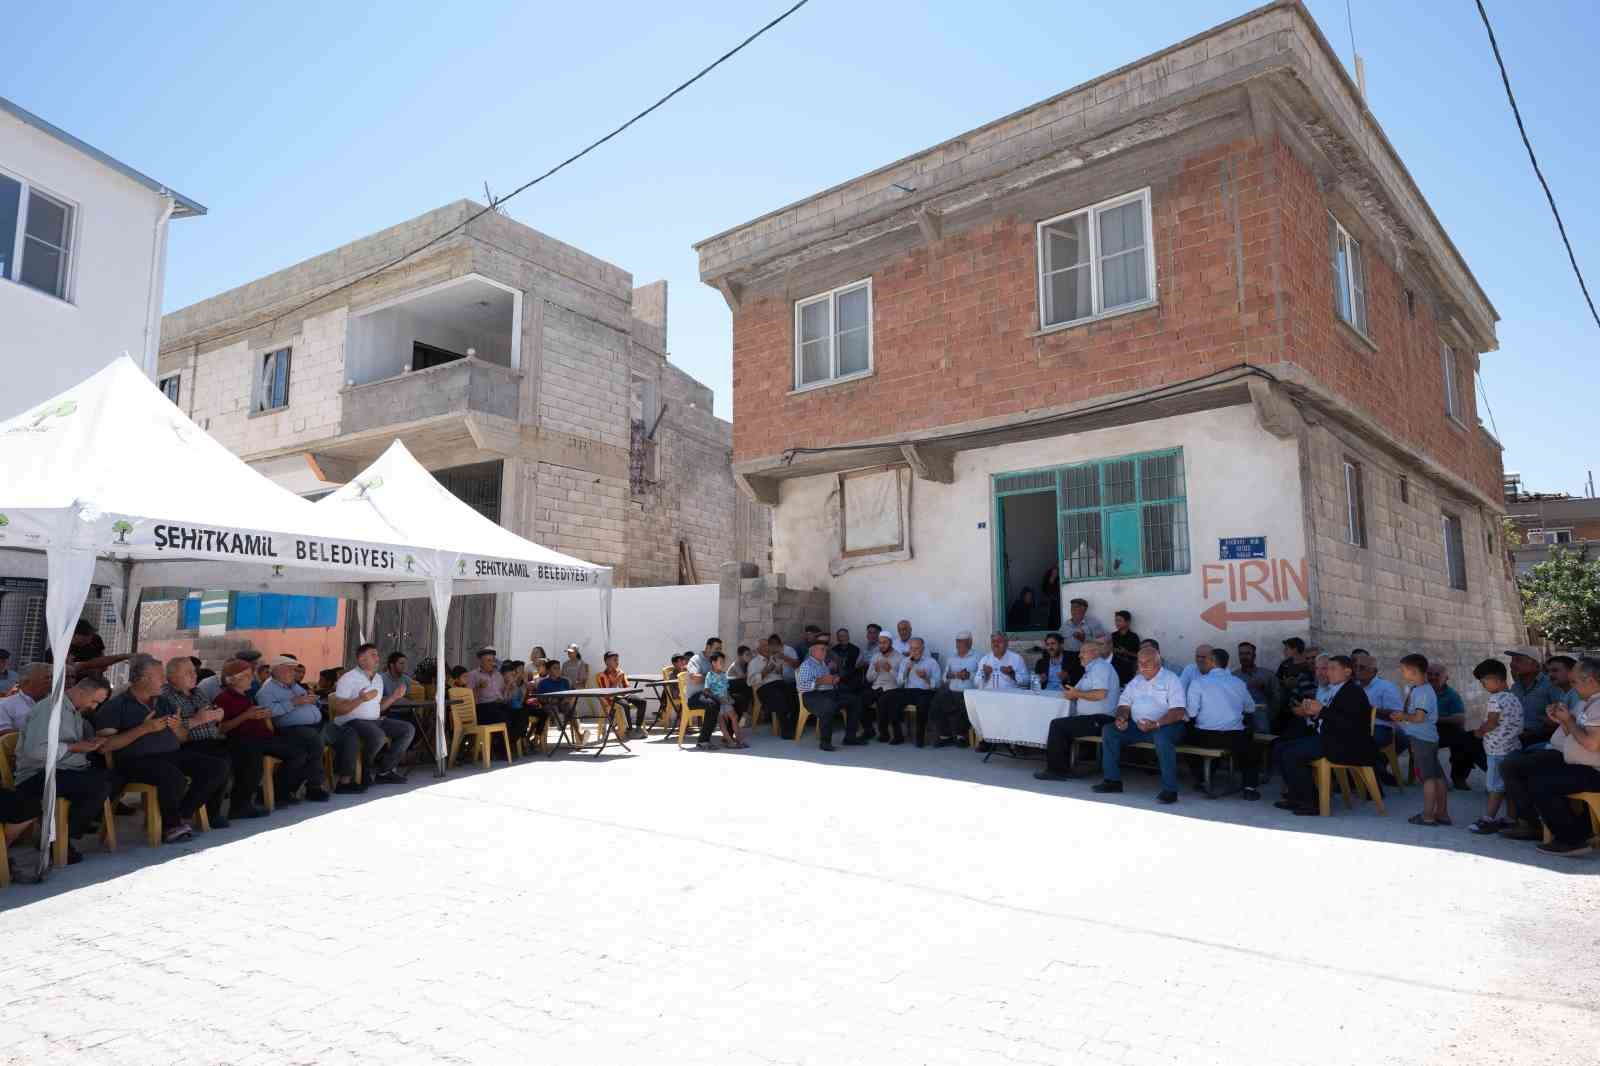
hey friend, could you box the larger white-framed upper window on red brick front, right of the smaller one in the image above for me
[1038,189,1155,330]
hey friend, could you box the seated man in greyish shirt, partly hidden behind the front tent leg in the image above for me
[8,674,110,863]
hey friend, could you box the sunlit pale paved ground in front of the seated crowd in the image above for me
[0,726,1600,1066]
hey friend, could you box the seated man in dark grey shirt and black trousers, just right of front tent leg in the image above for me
[93,655,229,844]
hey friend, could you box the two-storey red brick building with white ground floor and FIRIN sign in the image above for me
[696,3,1520,682]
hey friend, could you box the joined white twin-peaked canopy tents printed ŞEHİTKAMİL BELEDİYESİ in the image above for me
[0,355,611,855]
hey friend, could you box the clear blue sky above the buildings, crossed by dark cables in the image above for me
[0,0,1600,491]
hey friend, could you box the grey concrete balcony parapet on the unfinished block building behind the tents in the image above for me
[339,355,522,435]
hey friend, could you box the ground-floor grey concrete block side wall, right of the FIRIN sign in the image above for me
[1302,426,1525,704]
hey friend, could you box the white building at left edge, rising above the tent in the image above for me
[0,96,205,418]
